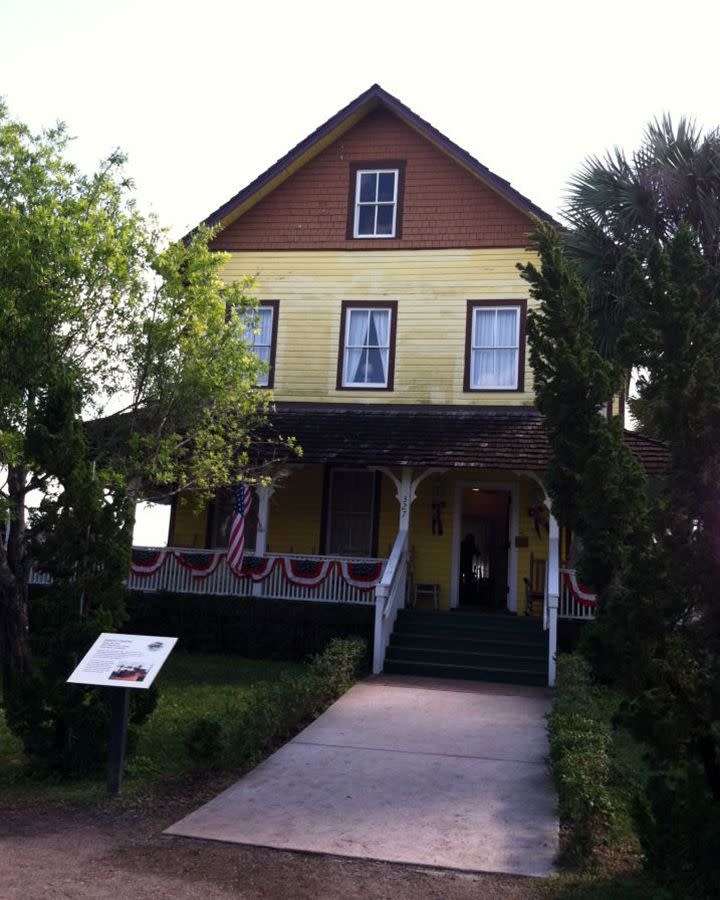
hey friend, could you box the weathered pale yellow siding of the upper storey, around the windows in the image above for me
[224,248,535,405]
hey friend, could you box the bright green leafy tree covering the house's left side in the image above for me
[0,107,290,687]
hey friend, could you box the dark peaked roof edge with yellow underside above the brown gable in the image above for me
[194,84,557,237]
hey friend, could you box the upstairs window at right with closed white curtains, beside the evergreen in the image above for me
[465,301,524,391]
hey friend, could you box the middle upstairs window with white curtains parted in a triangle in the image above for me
[338,303,395,390]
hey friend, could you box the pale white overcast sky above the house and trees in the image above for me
[0,0,720,540]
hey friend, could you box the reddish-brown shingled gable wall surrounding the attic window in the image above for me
[212,108,532,251]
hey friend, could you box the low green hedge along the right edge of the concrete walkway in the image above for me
[548,655,614,862]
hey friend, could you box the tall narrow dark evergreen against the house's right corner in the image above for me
[519,225,646,594]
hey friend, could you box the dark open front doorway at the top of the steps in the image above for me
[457,487,510,611]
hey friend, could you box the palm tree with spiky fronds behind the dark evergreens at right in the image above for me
[564,116,720,355]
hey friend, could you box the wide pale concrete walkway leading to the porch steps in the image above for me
[167,676,558,876]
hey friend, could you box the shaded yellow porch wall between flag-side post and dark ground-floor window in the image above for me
[267,466,323,554]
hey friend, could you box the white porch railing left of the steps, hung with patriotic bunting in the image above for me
[30,547,387,606]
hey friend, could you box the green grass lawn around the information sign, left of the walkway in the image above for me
[0,651,305,802]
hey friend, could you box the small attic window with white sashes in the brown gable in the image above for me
[348,162,404,238]
